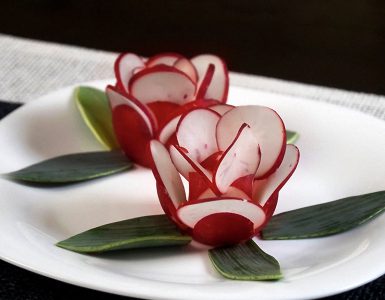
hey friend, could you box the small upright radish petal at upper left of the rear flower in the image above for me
[114,53,144,92]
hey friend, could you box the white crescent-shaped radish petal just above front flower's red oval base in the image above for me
[177,198,265,228]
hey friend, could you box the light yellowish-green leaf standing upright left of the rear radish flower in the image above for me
[74,86,119,149]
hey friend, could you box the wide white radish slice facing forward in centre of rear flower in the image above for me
[128,65,196,104]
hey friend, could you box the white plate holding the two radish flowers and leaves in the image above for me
[0,82,385,300]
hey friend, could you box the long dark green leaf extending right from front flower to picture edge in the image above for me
[262,191,385,240]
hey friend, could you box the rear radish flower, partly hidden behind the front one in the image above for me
[106,53,231,167]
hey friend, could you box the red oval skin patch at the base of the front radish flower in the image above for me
[192,213,254,247]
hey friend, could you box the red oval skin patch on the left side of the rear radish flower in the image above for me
[112,105,152,168]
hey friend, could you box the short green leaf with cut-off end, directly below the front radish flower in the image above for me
[209,240,282,280]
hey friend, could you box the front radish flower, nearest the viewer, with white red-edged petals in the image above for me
[149,105,299,246]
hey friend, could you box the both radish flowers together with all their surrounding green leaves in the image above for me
[4,53,385,280]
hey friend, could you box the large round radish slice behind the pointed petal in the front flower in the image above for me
[217,105,286,178]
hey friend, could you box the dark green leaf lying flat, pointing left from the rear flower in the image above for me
[3,151,133,184]
